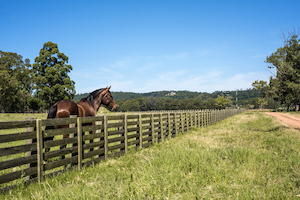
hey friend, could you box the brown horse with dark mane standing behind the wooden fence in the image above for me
[44,87,118,152]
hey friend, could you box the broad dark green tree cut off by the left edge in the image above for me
[0,50,32,112]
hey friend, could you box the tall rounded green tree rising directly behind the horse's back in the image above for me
[33,42,75,108]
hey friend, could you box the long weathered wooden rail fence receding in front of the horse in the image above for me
[0,109,243,190]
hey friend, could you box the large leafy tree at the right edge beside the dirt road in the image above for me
[266,32,300,109]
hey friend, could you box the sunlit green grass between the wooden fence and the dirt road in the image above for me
[0,111,300,199]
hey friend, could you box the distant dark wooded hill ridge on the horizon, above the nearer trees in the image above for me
[74,89,262,101]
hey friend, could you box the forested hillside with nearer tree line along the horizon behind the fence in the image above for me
[75,89,275,111]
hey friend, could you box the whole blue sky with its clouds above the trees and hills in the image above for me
[0,0,300,93]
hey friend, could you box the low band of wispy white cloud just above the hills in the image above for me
[107,71,268,92]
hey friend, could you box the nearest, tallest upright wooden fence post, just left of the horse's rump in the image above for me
[36,119,44,183]
